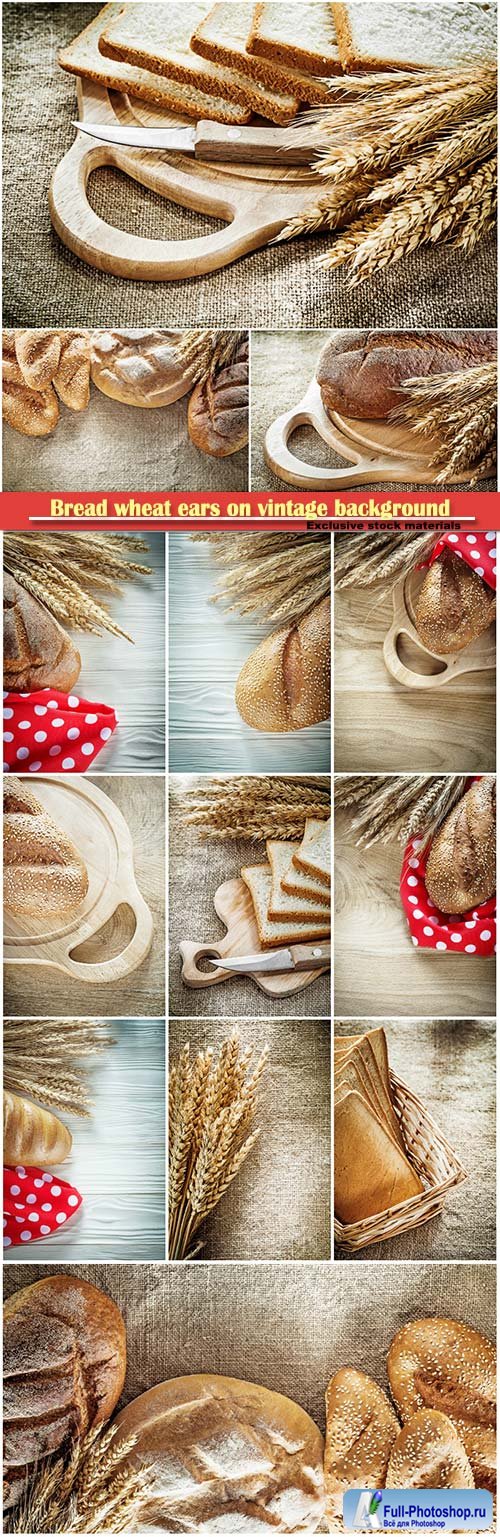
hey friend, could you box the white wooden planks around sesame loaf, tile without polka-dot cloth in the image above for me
[169,533,329,773]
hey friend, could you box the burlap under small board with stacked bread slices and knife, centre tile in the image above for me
[169,802,329,1019]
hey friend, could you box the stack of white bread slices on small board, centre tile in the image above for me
[242,818,331,950]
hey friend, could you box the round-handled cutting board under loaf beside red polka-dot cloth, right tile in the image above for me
[383,570,497,689]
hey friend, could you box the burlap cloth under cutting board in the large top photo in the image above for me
[3,5,495,329]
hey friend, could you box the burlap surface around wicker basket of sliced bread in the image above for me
[335,1019,495,1262]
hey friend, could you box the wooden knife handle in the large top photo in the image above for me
[194,121,309,166]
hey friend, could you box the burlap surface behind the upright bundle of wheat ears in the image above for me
[169,1019,331,1260]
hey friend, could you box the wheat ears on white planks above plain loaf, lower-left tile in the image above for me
[3,1019,115,1116]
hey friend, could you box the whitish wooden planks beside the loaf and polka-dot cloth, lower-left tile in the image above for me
[6,1019,166,1265]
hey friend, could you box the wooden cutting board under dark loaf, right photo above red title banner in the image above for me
[265,380,486,496]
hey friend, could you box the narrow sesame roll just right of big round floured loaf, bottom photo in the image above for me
[325,1366,400,1531]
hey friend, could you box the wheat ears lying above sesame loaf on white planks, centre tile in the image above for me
[192,532,331,624]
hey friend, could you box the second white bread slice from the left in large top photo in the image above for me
[98,0,297,121]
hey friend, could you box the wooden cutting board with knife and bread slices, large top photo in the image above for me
[49,80,317,280]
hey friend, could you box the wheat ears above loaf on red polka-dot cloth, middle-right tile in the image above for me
[335,773,468,848]
